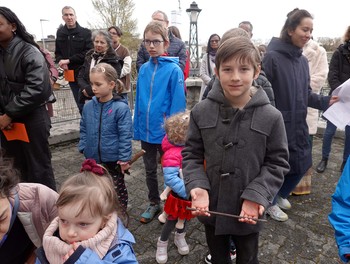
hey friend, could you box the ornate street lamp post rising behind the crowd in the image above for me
[186,1,202,76]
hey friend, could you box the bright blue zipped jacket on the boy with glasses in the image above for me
[134,57,186,144]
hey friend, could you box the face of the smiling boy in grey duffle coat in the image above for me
[215,57,259,108]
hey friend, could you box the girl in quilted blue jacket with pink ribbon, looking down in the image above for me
[78,63,132,214]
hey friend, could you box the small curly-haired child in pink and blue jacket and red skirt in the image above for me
[156,111,193,263]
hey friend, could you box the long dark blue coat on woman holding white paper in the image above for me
[263,38,329,174]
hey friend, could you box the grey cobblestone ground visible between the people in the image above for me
[52,137,343,264]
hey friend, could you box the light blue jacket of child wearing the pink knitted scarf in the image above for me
[35,219,138,264]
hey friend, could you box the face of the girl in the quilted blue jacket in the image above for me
[90,71,115,102]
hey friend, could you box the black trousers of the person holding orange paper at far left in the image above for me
[1,106,56,190]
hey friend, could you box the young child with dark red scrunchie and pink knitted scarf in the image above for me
[36,159,138,264]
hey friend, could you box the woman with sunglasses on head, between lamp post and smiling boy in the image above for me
[199,34,221,101]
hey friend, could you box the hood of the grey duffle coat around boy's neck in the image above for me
[207,78,270,109]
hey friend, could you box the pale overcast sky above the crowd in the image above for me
[0,0,350,44]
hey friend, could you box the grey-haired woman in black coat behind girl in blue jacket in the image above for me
[78,30,122,111]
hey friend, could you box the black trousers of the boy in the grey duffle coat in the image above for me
[204,225,259,264]
